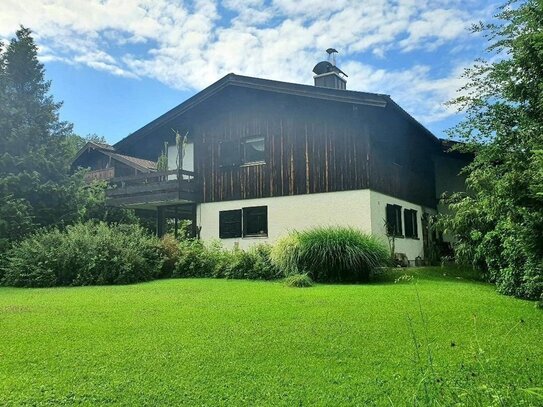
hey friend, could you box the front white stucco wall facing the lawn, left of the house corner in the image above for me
[197,189,372,248]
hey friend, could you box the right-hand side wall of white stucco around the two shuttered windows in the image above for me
[370,191,433,260]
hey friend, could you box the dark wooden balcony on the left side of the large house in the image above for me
[106,170,200,209]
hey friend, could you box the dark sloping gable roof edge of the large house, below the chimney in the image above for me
[115,73,439,149]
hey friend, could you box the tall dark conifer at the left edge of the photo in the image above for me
[0,27,89,250]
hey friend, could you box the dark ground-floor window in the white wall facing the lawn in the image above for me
[219,206,268,239]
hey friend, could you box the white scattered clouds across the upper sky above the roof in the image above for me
[0,0,488,125]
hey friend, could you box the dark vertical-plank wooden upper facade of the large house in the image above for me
[116,78,438,207]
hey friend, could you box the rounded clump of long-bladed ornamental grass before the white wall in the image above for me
[271,227,389,282]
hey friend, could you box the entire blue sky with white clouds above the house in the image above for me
[0,0,499,143]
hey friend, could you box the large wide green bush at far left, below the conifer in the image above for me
[2,223,164,287]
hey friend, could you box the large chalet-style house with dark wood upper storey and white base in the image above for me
[83,54,465,261]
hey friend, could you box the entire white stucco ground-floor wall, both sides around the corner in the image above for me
[197,189,433,261]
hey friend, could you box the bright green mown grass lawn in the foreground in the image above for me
[0,269,543,406]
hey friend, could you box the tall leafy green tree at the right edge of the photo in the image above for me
[442,0,543,299]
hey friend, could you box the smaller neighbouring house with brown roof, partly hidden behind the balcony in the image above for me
[72,141,157,181]
